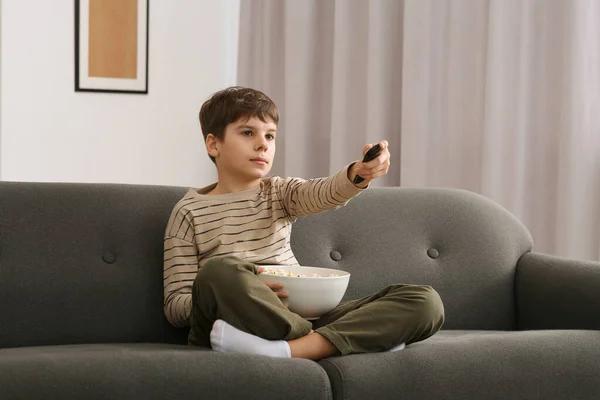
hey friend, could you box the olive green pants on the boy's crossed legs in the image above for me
[188,257,444,355]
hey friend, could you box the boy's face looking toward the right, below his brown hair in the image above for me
[209,117,277,180]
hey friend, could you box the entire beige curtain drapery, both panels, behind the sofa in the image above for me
[238,0,600,260]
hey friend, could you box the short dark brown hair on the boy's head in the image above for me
[198,86,279,163]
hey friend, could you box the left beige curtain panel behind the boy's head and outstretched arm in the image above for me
[238,0,403,186]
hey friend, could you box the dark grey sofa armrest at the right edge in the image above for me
[515,253,600,330]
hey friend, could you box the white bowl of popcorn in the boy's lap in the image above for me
[258,265,350,320]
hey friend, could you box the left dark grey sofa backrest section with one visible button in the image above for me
[0,182,187,348]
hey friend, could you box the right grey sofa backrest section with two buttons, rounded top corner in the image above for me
[291,188,533,330]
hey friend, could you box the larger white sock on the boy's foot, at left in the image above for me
[210,319,292,358]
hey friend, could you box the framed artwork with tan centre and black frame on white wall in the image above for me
[75,0,150,94]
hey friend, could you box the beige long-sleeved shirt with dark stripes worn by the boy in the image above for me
[163,167,362,327]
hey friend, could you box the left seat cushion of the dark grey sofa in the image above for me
[0,344,331,400]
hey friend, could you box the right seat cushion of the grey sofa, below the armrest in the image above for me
[319,330,600,400]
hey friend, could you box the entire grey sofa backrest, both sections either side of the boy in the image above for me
[0,182,531,348]
